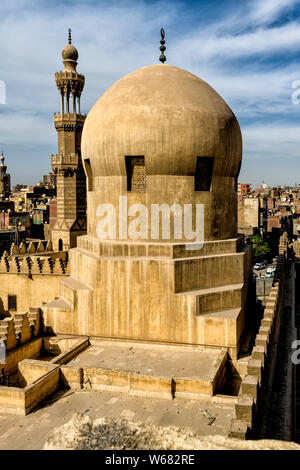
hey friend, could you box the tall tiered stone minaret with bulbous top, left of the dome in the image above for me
[51,29,86,250]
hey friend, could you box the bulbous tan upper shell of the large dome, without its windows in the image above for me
[81,64,242,177]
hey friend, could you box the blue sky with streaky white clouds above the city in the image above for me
[0,0,300,187]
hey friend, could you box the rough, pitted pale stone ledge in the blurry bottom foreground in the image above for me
[44,414,300,450]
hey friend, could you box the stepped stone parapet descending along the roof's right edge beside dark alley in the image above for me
[229,256,285,439]
